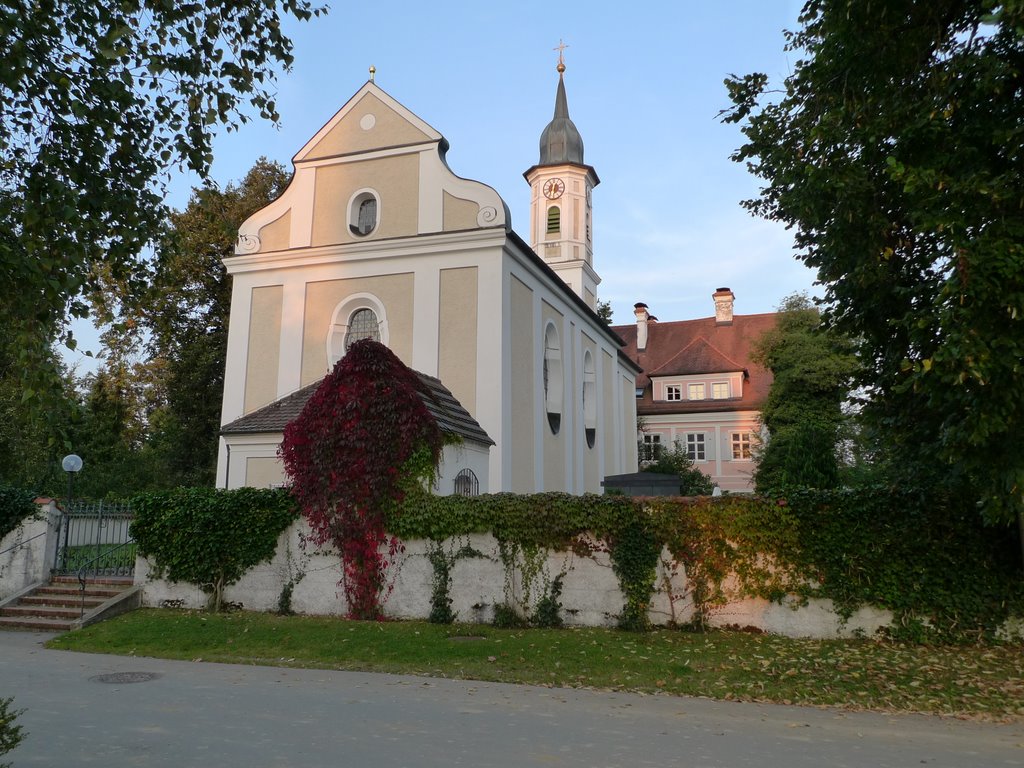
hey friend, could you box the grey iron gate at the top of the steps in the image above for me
[53,502,135,577]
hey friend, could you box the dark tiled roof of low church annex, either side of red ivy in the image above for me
[220,372,495,445]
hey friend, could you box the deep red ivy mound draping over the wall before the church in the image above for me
[281,339,443,618]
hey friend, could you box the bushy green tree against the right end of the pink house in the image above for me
[752,294,856,493]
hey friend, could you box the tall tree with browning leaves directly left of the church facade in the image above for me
[142,158,291,485]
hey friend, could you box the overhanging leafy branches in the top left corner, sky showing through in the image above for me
[0,0,324,434]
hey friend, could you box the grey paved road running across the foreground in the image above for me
[0,632,1024,768]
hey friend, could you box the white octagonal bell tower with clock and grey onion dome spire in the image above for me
[523,42,601,309]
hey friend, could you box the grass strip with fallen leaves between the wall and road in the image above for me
[41,608,1024,720]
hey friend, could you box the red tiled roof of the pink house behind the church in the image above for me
[611,312,775,416]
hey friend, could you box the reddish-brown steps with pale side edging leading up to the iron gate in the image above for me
[0,575,138,632]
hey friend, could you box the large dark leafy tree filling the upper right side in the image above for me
[725,0,1024,520]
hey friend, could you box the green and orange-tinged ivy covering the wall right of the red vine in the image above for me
[388,487,1024,641]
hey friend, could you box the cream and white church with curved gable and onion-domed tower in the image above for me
[217,59,639,494]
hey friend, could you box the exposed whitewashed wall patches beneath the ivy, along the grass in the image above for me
[135,522,892,638]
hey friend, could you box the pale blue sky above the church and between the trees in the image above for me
[66,0,815,372]
